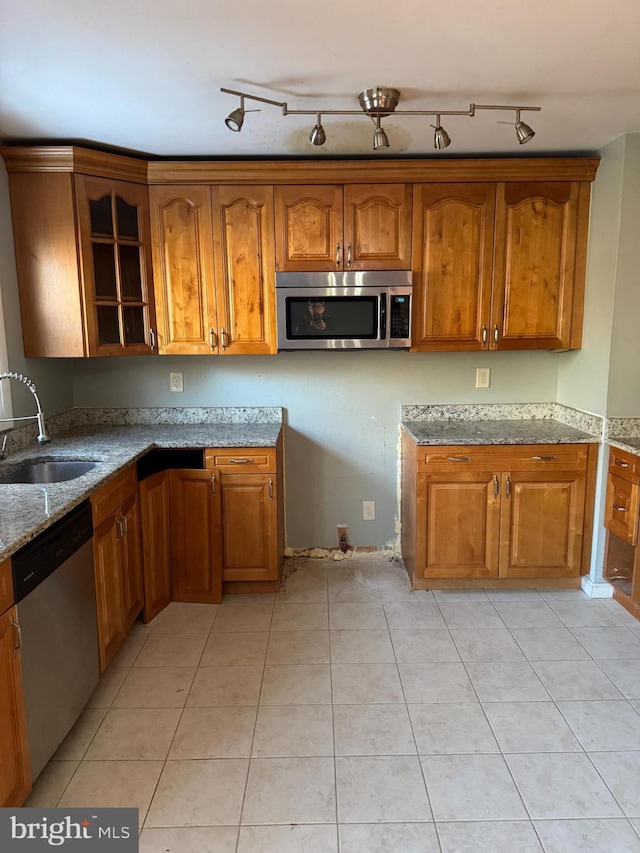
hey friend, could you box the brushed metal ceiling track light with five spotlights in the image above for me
[220,86,540,151]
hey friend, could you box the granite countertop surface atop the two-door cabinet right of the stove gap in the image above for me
[402,419,599,446]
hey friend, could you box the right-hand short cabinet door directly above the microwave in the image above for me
[344,184,411,270]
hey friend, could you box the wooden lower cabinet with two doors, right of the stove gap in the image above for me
[402,434,597,586]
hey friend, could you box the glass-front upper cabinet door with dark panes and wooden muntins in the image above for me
[76,175,156,355]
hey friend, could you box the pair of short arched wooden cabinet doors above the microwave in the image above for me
[275,184,411,272]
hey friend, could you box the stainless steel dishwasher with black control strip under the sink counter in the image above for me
[12,503,100,779]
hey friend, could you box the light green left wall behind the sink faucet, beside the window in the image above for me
[0,157,73,415]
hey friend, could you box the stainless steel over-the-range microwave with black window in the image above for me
[276,270,413,350]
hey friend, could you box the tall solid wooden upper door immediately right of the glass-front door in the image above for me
[150,186,217,355]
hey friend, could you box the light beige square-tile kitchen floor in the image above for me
[28,554,640,853]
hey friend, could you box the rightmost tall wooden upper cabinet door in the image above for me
[491,181,580,349]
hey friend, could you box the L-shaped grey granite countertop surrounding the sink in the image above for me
[0,422,282,560]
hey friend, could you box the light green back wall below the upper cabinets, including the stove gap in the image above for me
[74,351,562,547]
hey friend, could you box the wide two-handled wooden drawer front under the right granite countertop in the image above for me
[417,444,589,472]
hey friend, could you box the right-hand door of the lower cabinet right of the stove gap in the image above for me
[500,471,586,578]
